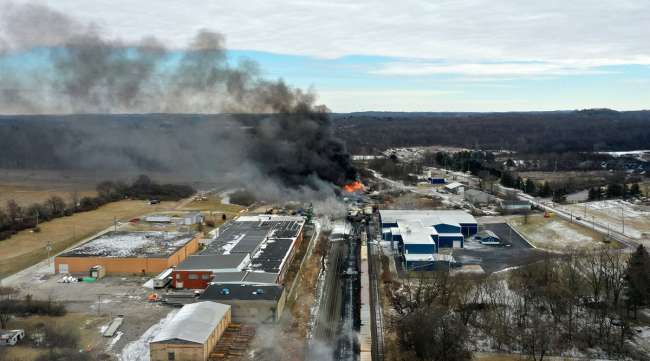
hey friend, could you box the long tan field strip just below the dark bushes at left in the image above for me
[0,200,179,276]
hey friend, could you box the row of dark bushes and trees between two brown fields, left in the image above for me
[0,175,195,240]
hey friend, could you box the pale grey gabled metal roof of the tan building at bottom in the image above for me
[151,302,230,344]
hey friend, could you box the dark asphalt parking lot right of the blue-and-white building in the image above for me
[453,223,546,273]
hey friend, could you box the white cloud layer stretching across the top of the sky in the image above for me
[5,0,650,67]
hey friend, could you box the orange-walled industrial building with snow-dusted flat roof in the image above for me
[54,231,199,274]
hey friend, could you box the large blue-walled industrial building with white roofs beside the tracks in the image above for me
[379,210,478,269]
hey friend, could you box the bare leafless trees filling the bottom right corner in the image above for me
[386,246,650,361]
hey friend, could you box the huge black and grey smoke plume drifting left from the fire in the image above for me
[0,4,355,189]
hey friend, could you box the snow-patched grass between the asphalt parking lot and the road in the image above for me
[510,214,619,251]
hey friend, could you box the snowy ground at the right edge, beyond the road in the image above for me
[560,199,650,239]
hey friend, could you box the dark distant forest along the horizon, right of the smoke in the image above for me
[333,109,650,154]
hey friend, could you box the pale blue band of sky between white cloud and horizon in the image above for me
[230,51,650,112]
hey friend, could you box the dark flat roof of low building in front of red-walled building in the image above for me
[199,283,284,302]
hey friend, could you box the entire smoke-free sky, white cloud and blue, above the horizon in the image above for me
[0,0,650,111]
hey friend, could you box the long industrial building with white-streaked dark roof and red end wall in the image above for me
[172,214,305,289]
